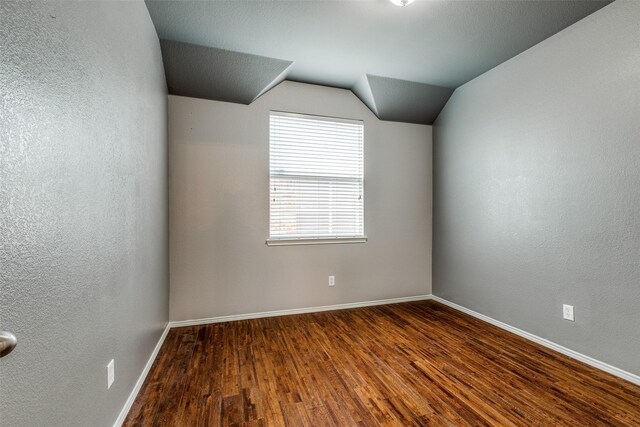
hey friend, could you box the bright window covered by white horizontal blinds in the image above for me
[267,111,366,245]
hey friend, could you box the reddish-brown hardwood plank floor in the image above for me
[125,301,640,427]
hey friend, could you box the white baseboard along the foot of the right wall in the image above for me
[432,295,640,385]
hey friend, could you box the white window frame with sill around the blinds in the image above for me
[265,110,368,246]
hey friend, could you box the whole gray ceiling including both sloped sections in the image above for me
[146,0,610,124]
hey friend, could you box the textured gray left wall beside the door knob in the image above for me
[0,2,168,426]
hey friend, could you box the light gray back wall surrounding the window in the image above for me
[169,81,432,320]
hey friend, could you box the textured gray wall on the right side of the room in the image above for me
[434,0,640,374]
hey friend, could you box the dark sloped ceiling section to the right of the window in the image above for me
[352,74,453,125]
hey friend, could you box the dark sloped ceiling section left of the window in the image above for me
[160,40,293,105]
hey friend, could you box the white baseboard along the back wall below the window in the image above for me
[169,294,431,328]
